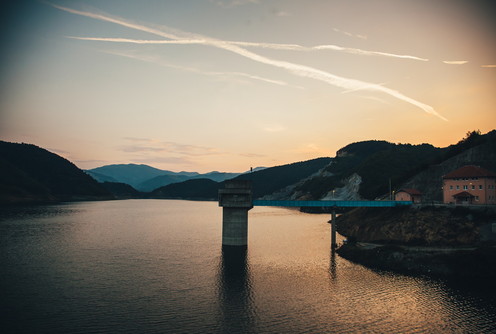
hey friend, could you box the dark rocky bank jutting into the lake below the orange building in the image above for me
[337,206,496,279]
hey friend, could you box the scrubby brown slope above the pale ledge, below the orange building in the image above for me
[337,207,494,246]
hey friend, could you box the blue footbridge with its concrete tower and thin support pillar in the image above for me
[219,180,412,249]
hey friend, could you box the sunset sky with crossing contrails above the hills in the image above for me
[0,0,496,172]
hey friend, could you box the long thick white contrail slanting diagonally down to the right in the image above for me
[52,4,447,121]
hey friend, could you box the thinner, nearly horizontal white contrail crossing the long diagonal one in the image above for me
[68,36,429,61]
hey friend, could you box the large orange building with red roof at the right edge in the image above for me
[443,165,496,204]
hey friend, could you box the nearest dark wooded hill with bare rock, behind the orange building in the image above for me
[293,130,496,200]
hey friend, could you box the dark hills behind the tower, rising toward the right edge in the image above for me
[144,130,496,201]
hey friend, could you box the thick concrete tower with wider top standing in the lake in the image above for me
[219,180,253,248]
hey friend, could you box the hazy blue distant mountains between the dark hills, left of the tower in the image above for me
[86,164,254,192]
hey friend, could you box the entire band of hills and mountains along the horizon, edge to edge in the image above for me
[0,130,496,204]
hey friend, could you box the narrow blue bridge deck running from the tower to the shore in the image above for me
[253,200,412,208]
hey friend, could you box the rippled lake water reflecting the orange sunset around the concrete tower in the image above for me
[0,200,496,333]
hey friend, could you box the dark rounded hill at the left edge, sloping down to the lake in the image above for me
[0,141,113,204]
